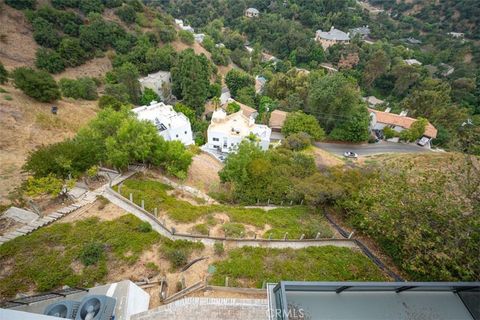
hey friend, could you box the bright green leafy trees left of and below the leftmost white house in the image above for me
[23,107,192,198]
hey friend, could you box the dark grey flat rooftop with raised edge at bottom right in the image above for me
[268,281,480,320]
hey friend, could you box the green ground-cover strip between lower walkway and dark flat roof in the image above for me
[210,246,388,288]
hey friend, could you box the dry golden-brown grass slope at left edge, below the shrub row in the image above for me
[0,85,97,203]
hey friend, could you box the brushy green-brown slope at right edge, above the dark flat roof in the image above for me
[337,153,480,281]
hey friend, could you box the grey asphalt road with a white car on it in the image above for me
[315,141,431,156]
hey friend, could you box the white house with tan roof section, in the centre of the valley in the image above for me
[207,108,272,153]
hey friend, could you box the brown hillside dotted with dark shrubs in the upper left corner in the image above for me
[0,0,232,204]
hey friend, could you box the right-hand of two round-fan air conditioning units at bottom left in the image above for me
[75,295,117,320]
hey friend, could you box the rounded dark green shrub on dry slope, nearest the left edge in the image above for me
[13,67,60,102]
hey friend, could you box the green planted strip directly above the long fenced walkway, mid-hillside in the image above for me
[116,179,333,239]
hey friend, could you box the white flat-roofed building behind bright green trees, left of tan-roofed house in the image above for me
[132,101,193,146]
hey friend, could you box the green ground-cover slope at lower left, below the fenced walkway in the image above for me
[0,214,203,299]
